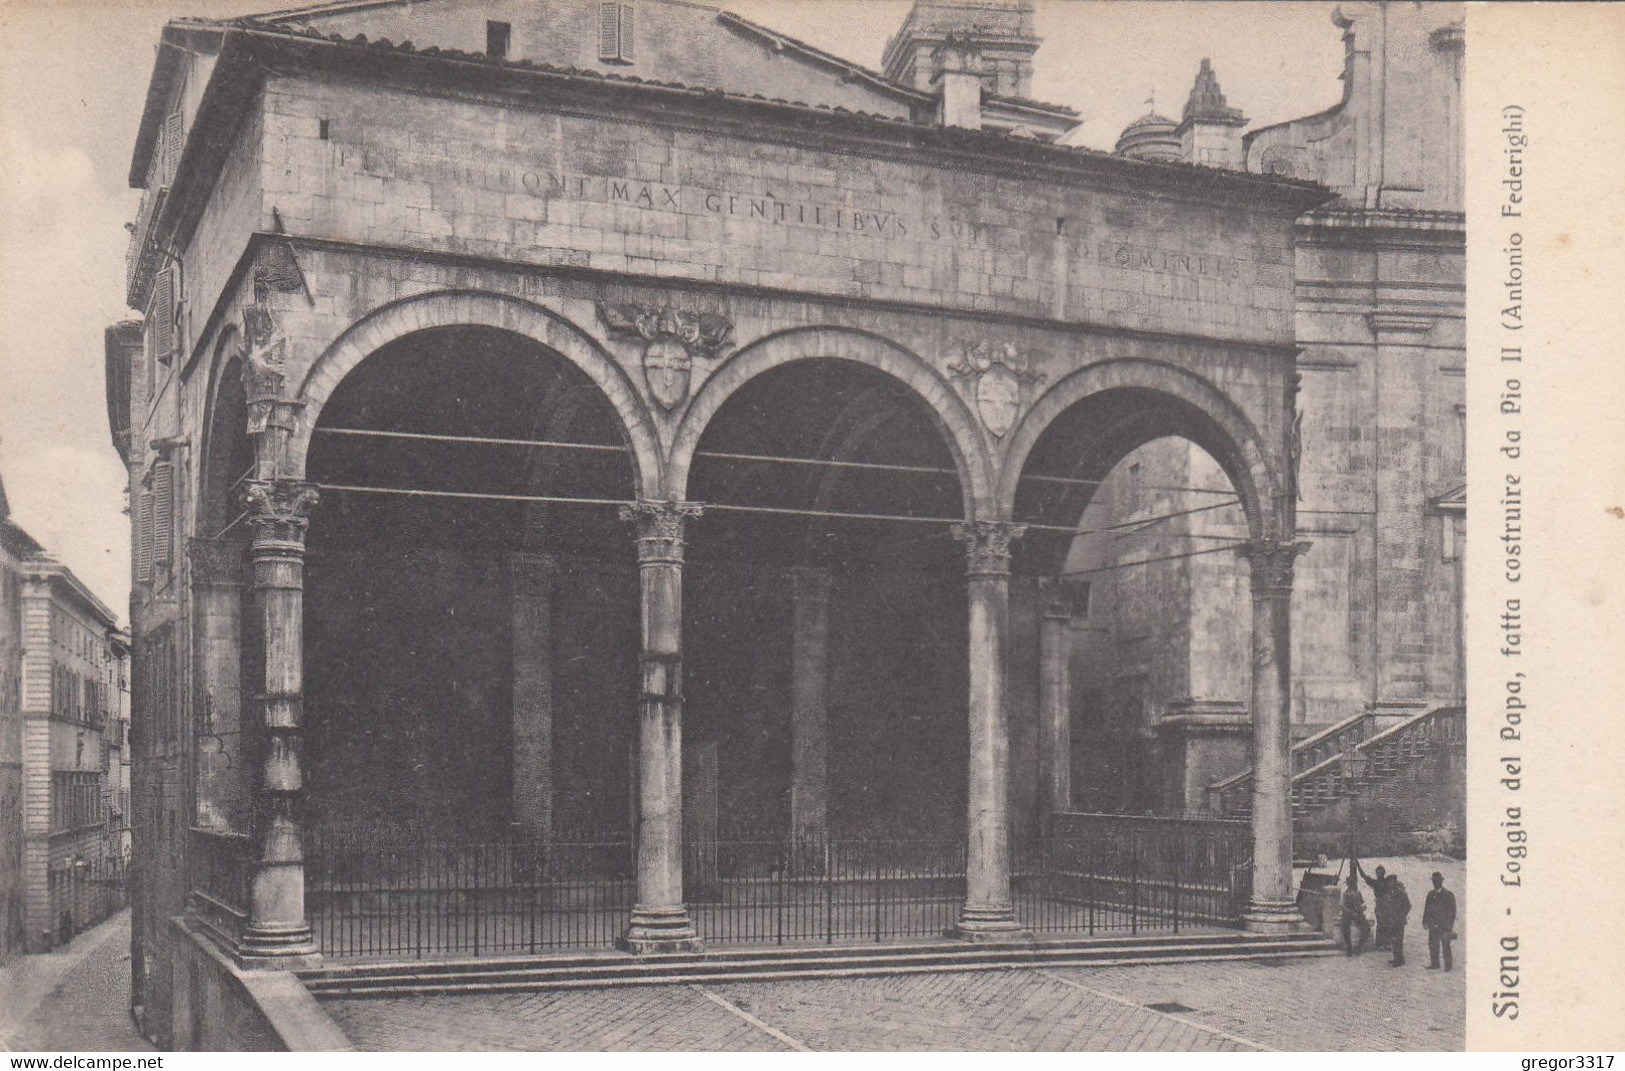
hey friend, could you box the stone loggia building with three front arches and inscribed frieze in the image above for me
[107,0,1462,1045]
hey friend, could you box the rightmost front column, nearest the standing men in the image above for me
[1237,540,1310,933]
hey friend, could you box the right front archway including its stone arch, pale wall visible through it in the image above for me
[1004,377,1297,925]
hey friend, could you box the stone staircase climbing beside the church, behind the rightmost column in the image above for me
[1207,707,1466,819]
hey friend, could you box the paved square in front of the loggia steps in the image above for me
[327,936,1464,1051]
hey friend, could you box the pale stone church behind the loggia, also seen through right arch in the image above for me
[1074,3,1466,829]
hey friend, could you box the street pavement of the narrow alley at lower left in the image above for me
[0,910,153,1053]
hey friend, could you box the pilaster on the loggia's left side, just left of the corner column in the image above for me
[187,540,252,834]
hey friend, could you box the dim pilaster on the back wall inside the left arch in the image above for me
[510,553,556,842]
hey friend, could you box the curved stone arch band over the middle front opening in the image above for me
[665,327,993,517]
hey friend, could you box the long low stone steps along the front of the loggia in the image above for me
[299,931,1336,999]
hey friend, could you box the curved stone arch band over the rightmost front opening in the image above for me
[998,358,1292,540]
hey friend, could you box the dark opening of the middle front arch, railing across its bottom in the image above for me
[684,358,969,941]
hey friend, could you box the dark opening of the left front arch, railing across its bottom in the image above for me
[304,325,639,952]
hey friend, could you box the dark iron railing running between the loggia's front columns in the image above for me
[306,814,1251,957]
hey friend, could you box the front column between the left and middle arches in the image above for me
[619,501,700,956]
